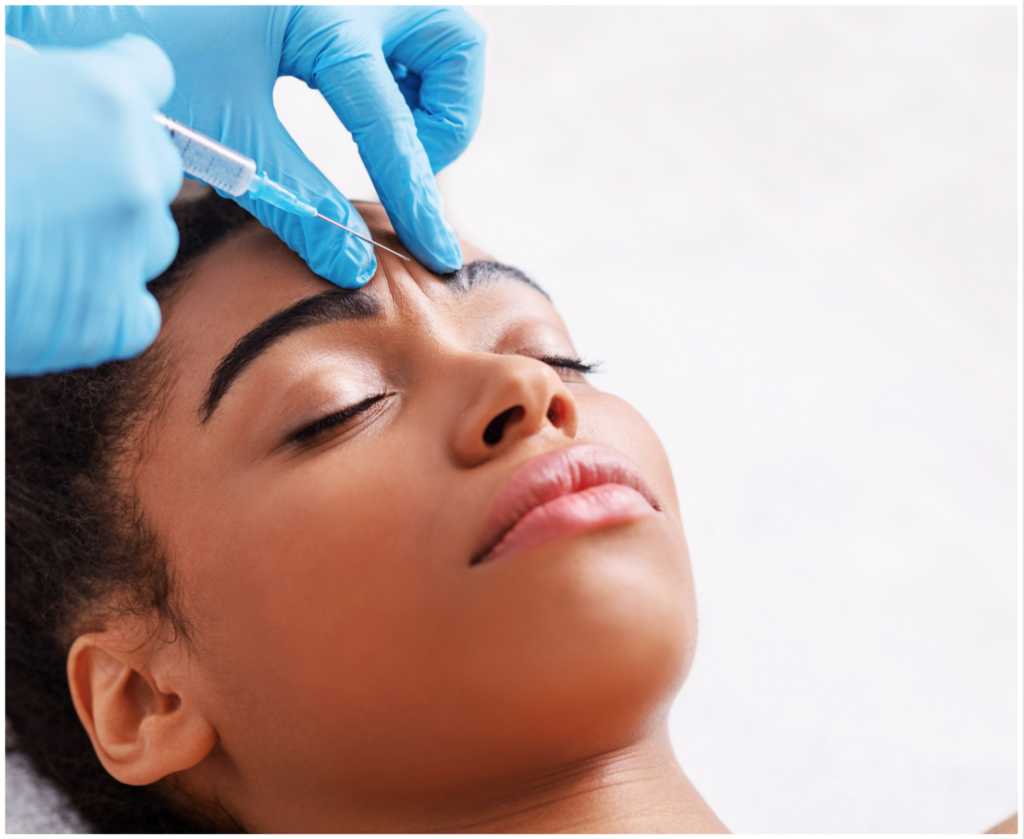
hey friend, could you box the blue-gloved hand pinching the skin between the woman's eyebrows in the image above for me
[6,6,484,287]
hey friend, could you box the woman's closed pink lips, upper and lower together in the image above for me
[470,445,662,565]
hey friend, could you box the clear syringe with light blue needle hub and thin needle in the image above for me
[153,114,412,262]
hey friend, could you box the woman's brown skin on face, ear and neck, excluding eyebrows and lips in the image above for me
[69,205,725,833]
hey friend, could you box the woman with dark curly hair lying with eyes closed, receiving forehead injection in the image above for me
[7,196,725,832]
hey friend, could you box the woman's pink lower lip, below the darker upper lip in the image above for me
[480,484,655,562]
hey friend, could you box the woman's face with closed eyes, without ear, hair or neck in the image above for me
[137,206,696,829]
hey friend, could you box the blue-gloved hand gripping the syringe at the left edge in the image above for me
[5,36,181,375]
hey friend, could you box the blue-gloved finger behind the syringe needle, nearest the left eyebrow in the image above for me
[221,112,377,288]
